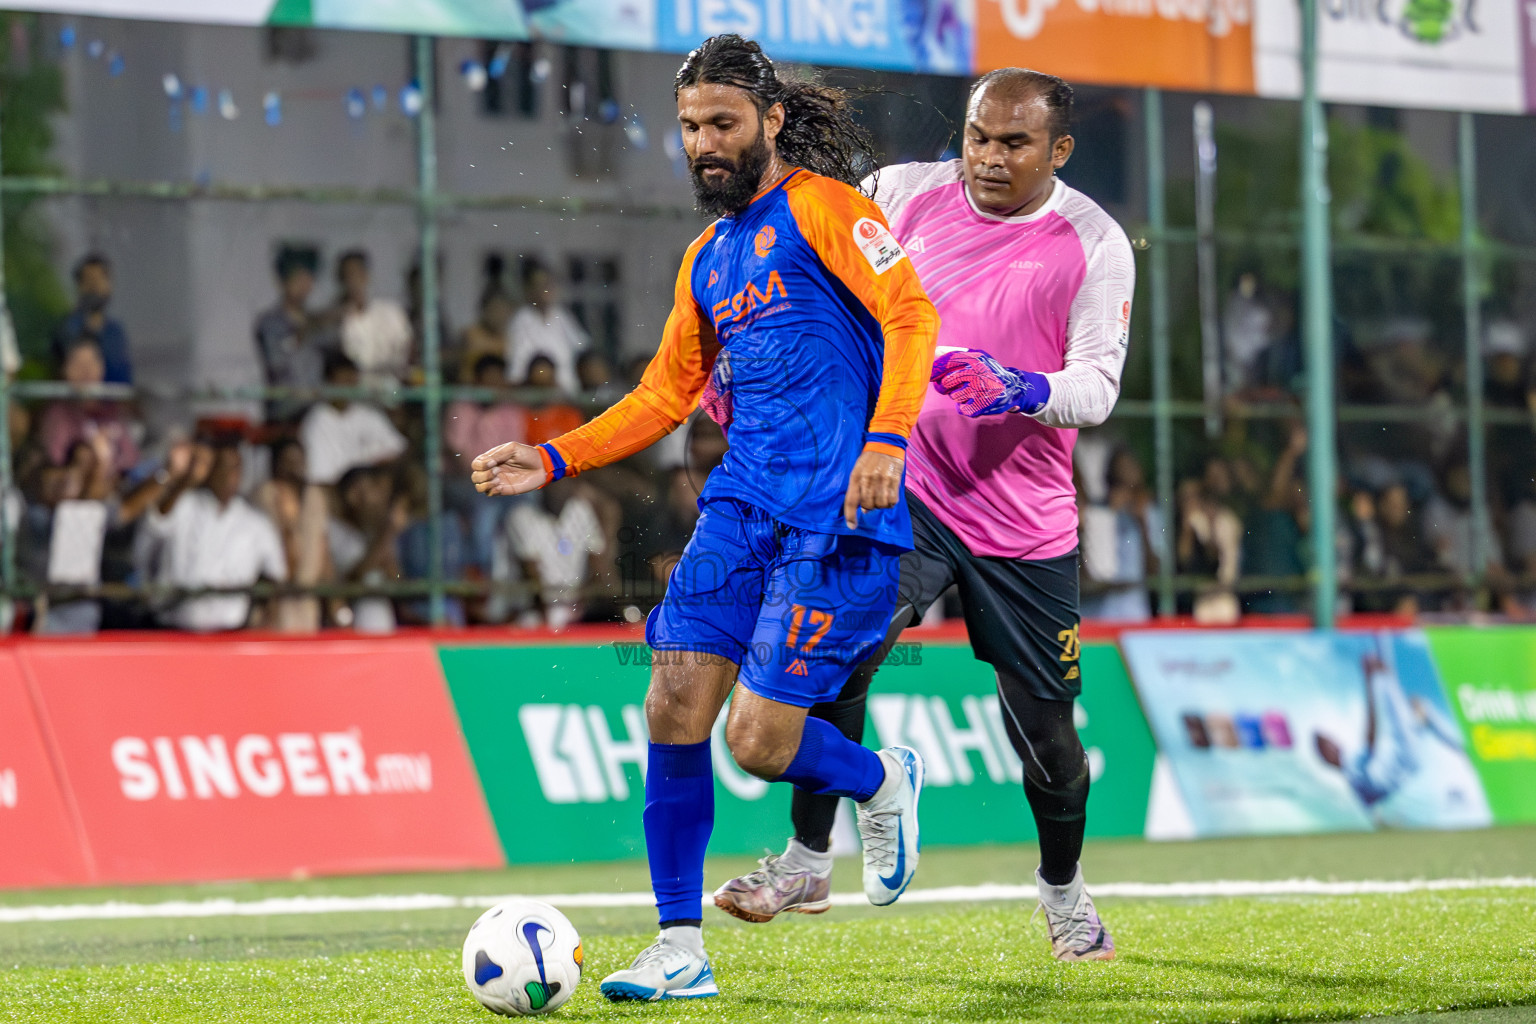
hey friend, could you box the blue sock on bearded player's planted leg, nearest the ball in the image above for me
[644,740,714,924]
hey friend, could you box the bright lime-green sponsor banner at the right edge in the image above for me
[1425,626,1536,824]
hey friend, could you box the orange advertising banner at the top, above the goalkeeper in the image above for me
[975,0,1253,94]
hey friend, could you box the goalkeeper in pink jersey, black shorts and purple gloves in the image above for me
[714,68,1135,960]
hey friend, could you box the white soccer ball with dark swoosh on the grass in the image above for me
[464,900,582,1016]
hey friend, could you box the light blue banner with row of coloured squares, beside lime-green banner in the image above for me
[1120,631,1491,835]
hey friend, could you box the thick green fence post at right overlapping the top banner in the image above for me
[1301,0,1338,629]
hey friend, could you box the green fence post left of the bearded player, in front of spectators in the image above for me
[413,35,447,626]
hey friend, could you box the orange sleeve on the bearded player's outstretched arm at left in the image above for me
[539,226,720,481]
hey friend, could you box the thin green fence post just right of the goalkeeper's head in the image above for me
[1141,89,1175,616]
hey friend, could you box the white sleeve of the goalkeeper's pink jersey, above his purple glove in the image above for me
[1034,211,1137,428]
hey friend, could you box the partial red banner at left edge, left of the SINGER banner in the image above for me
[0,651,91,889]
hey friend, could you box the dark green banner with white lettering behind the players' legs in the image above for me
[439,643,1154,863]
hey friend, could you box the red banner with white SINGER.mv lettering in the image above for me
[17,640,505,881]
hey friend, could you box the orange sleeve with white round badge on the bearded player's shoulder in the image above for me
[790,178,938,456]
